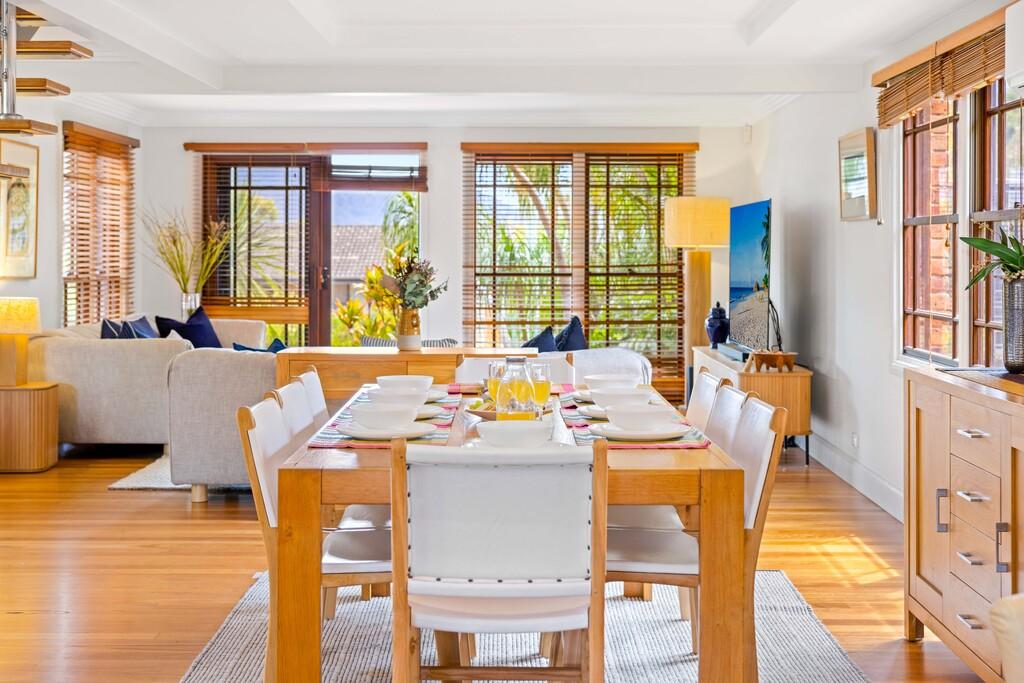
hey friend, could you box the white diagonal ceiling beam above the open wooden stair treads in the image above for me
[18,0,222,90]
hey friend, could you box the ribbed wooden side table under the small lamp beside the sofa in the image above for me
[0,382,57,472]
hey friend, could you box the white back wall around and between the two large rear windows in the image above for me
[139,127,753,338]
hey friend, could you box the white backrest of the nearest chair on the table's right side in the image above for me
[726,398,782,528]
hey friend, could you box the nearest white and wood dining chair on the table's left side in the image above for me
[237,397,391,680]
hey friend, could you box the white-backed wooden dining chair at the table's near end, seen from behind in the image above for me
[391,440,607,683]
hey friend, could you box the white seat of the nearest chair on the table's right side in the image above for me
[607,528,700,574]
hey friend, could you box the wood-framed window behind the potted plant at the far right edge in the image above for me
[971,79,1024,367]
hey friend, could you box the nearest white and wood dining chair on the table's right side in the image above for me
[607,398,787,663]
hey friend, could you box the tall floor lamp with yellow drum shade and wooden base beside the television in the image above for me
[665,197,729,398]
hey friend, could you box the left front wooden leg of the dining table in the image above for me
[274,468,322,683]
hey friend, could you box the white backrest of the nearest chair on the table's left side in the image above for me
[236,396,296,528]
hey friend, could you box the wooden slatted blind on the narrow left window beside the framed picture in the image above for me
[62,122,138,325]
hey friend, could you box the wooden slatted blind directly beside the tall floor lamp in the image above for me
[585,154,696,378]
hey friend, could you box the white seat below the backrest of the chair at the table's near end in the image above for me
[409,595,590,633]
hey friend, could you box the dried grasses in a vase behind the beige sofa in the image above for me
[142,214,231,318]
